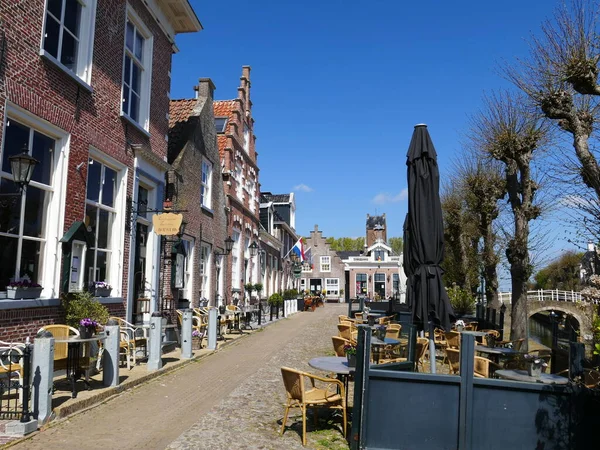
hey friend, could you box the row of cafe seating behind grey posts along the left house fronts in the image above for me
[0,302,295,436]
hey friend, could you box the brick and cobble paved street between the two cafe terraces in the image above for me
[12,304,347,450]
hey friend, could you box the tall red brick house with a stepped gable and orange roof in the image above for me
[214,66,260,303]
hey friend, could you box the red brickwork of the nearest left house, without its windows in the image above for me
[0,0,191,339]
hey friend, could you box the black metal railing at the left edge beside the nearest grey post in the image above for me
[0,343,32,422]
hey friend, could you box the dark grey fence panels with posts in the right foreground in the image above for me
[350,326,600,450]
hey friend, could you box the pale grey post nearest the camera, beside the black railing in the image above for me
[31,331,54,425]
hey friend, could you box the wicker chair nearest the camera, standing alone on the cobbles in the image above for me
[279,367,347,445]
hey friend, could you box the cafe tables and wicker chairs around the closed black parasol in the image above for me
[280,308,600,448]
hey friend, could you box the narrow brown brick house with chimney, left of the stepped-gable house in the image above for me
[169,78,231,306]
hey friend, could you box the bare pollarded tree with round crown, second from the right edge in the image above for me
[469,92,547,350]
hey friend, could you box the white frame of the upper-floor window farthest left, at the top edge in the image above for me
[40,0,96,90]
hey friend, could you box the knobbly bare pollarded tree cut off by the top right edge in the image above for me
[505,0,600,240]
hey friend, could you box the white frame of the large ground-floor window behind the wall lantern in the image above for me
[0,102,70,298]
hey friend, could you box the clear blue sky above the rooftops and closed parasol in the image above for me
[171,0,576,278]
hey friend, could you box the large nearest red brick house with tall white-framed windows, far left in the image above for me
[0,0,201,340]
